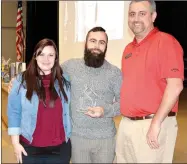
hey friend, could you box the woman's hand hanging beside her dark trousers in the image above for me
[13,143,27,163]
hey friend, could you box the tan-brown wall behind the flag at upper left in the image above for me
[1,1,26,62]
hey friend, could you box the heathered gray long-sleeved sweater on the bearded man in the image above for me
[62,59,122,139]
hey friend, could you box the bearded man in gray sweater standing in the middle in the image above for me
[62,27,122,163]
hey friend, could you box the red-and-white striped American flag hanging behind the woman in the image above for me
[16,1,25,61]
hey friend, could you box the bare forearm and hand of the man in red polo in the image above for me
[147,78,183,149]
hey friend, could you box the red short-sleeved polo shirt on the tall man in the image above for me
[121,28,184,117]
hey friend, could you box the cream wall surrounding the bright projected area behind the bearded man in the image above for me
[59,1,133,68]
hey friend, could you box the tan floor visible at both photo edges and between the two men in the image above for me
[1,88,187,163]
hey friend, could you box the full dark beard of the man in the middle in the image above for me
[84,48,106,68]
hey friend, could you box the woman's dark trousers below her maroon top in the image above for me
[20,140,71,164]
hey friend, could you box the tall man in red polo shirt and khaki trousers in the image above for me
[116,0,184,163]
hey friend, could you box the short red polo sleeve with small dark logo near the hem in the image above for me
[158,35,184,80]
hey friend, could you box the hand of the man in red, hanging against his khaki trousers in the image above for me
[147,123,161,149]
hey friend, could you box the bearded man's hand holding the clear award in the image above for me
[84,107,104,118]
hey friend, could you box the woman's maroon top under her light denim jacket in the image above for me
[20,75,65,147]
